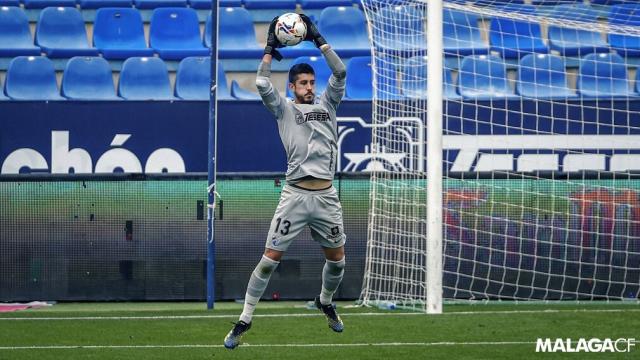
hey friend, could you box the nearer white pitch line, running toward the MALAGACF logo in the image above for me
[0,341,535,350]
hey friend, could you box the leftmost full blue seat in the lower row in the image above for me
[4,56,64,100]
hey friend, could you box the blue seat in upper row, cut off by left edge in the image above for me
[0,6,40,57]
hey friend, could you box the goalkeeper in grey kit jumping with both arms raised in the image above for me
[224,15,346,349]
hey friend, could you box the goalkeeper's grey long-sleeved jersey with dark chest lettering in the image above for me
[256,50,345,183]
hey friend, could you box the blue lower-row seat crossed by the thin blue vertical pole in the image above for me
[175,57,231,101]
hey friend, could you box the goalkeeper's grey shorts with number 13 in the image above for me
[265,184,346,251]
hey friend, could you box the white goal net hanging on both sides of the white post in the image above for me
[360,0,640,310]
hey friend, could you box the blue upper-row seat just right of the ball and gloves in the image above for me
[318,6,371,57]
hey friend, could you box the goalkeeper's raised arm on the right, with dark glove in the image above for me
[300,14,347,107]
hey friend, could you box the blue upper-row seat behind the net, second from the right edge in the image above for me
[549,5,609,56]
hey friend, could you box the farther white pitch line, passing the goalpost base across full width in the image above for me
[0,309,640,321]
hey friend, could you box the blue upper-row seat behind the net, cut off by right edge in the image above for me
[609,3,640,57]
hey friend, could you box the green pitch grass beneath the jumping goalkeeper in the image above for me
[0,302,640,360]
